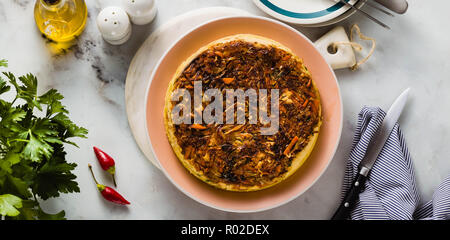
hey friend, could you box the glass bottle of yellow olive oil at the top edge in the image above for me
[34,0,87,42]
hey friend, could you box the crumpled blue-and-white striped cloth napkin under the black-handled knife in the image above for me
[343,107,450,220]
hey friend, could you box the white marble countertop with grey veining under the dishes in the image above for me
[0,0,450,219]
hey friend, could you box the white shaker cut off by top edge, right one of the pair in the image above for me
[122,0,157,25]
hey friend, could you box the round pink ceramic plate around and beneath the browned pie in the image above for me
[146,17,342,212]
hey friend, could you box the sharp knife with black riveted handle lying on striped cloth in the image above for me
[331,88,409,220]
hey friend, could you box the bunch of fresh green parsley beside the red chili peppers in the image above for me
[0,60,88,219]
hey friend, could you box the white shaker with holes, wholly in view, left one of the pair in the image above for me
[97,6,131,45]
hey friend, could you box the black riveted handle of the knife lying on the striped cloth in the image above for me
[331,173,367,220]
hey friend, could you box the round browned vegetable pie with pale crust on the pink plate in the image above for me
[164,34,322,192]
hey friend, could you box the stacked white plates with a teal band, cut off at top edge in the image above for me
[253,0,366,27]
